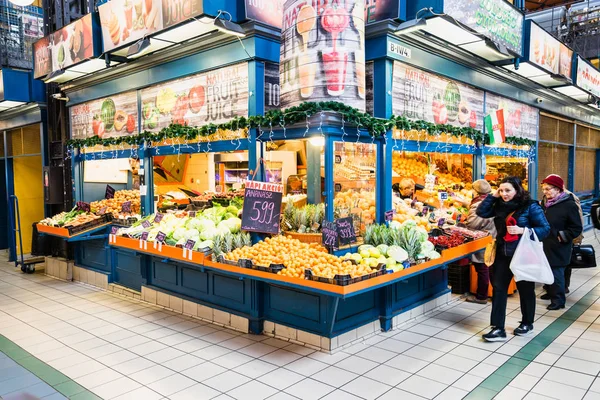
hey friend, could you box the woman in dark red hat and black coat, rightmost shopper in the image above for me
[542,175,583,310]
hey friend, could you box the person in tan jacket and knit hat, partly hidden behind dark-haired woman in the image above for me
[465,179,496,304]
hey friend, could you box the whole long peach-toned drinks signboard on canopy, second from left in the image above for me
[98,0,204,52]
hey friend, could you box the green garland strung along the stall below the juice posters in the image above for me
[67,101,535,148]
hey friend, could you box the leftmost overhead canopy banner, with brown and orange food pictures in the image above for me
[33,14,94,79]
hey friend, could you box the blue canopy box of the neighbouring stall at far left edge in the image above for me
[0,68,46,112]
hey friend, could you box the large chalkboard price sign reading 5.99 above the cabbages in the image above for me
[242,181,283,234]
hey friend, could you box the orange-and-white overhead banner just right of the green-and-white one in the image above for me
[529,23,573,78]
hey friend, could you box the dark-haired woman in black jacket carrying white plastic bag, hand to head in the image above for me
[477,177,550,342]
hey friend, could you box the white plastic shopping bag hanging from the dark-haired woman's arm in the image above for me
[510,228,554,285]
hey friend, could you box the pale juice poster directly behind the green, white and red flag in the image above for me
[485,93,539,140]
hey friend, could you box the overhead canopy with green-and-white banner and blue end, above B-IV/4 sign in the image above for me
[404,0,524,62]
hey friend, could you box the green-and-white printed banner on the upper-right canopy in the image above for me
[444,0,523,55]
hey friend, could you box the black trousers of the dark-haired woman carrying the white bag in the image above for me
[490,252,535,329]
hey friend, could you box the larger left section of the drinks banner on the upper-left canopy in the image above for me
[98,0,163,52]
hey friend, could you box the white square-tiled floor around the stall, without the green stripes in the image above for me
[0,239,600,400]
